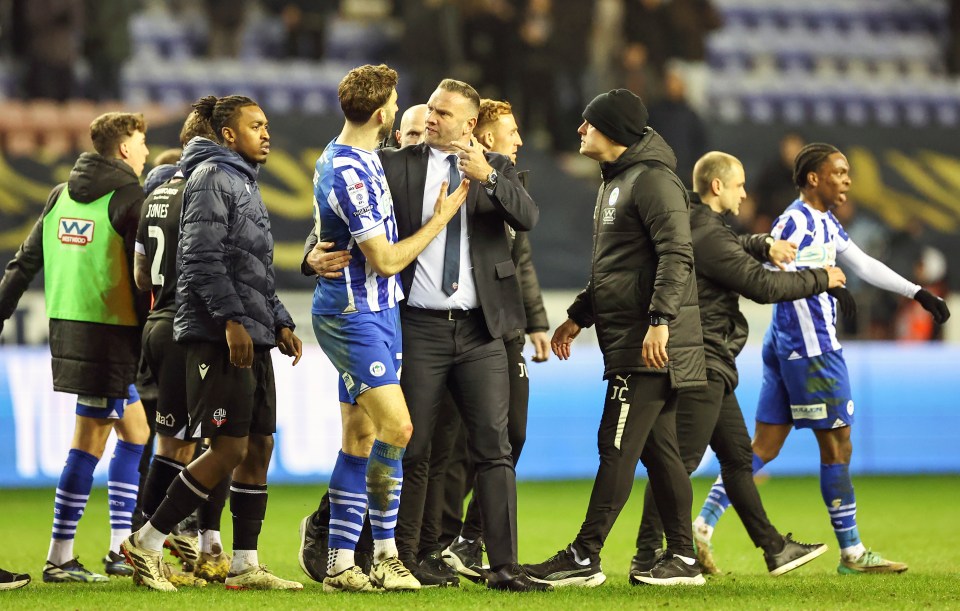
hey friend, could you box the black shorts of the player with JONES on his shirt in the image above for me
[143,317,191,441]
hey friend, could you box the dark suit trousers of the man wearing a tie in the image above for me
[396,308,517,567]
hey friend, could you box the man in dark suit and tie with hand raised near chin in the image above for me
[381,79,542,591]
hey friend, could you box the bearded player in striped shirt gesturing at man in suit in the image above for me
[312,64,469,591]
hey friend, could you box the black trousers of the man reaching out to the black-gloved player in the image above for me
[637,371,781,552]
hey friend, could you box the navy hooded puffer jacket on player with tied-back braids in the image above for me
[173,137,294,348]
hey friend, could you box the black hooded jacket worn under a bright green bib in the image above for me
[0,153,146,398]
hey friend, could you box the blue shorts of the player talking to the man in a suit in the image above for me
[313,308,403,404]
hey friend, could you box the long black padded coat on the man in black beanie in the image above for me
[567,128,706,388]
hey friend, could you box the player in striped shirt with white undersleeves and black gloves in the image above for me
[694,143,950,575]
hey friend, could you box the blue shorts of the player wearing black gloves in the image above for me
[757,333,853,429]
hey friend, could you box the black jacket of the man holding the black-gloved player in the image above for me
[690,200,829,390]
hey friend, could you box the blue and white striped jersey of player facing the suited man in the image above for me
[312,140,403,314]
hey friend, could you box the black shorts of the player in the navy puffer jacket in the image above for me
[184,342,277,438]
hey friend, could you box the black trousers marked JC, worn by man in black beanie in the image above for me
[573,374,694,558]
